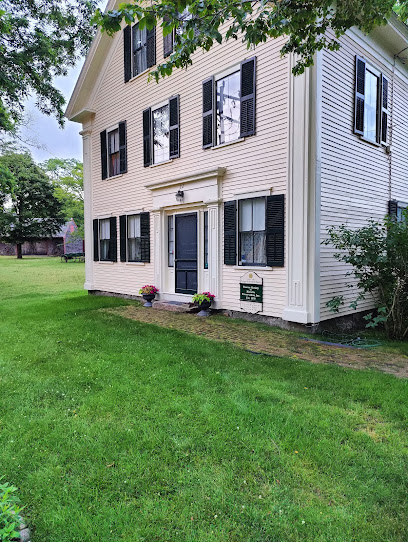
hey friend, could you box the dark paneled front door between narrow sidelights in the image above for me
[175,213,197,294]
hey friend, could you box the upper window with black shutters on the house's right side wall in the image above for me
[354,56,388,144]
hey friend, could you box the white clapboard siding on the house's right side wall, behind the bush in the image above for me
[320,33,408,320]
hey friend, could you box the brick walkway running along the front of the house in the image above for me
[103,304,408,378]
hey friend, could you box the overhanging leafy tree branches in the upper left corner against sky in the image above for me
[0,0,97,132]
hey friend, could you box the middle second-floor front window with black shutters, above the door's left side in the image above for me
[143,96,180,167]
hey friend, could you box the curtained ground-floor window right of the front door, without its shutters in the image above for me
[239,198,266,265]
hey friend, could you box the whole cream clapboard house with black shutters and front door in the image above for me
[66,1,408,325]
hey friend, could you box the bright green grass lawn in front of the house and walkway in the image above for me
[0,258,408,542]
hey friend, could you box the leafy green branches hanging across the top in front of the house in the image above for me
[94,0,408,80]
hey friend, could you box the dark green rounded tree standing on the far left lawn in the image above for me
[0,153,64,258]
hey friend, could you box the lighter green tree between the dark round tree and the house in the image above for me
[40,158,84,236]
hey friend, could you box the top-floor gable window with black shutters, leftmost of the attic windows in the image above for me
[123,23,156,83]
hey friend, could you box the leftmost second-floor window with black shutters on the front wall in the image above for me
[100,122,127,179]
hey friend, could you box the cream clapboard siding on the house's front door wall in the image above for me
[90,23,289,317]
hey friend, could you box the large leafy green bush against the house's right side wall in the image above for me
[323,211,408,340]
